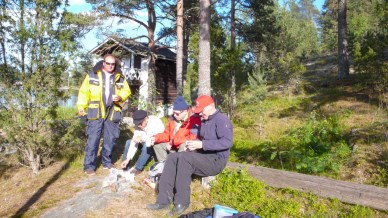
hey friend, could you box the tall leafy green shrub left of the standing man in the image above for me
[0,0,94,174]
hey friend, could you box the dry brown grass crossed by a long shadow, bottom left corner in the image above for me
[0,158,83,217]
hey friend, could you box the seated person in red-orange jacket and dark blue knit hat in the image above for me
[151,96,201,161]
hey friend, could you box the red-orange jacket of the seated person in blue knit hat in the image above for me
[155,108,201,149]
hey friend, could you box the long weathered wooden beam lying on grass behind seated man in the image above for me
[227,162,388,210]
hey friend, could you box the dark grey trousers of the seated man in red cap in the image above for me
[156,152,228,205]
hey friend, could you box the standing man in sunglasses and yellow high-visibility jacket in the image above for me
[77,54,131,175]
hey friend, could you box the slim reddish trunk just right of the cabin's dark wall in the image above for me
[176,0,184,95]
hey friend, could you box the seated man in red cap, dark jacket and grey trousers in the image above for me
[146,95,233,216]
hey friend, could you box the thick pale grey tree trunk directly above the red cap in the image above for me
[198,0,211,95]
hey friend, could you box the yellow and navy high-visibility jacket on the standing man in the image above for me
[77,70,131,122]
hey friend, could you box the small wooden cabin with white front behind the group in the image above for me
[89,37,177,115]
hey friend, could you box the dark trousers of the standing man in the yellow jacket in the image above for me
[84,119,120,170]
